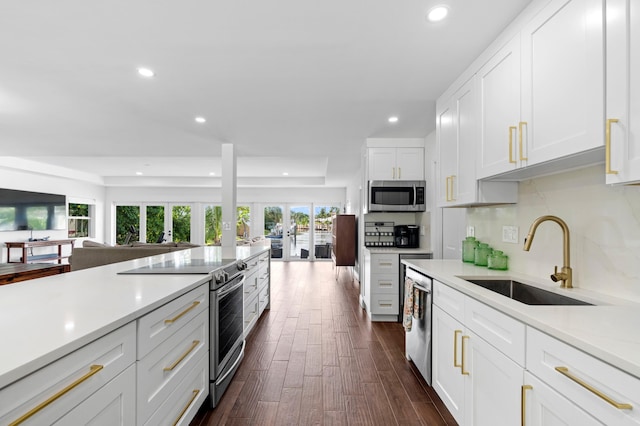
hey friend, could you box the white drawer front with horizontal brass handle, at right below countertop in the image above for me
[527,327,640,425]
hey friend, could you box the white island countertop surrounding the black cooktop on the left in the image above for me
[0,246,268,389]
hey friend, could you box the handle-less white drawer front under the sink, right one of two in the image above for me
[464,297,526,367]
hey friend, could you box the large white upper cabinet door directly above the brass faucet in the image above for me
[518,0,604,165]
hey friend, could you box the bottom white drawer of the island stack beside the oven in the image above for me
[139,352,209,426]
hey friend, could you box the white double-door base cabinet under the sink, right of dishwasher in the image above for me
[433,280,525,425]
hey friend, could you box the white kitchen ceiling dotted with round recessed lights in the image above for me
[0,0,530,186]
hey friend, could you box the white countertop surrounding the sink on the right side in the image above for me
[403,260,640,378]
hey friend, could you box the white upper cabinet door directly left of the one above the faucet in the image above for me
[478,35,522,179]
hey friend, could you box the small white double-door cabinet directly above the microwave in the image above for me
[368,147,424,180]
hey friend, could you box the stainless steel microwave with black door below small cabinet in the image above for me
[368,180,426,212]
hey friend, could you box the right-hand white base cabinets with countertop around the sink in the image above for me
[403,260,640,425]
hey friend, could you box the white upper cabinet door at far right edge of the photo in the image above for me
[605,0,640,184]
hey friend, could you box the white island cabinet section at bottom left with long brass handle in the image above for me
[0,323,136,425]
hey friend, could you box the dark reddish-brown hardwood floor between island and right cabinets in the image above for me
[191,262,456,426]
